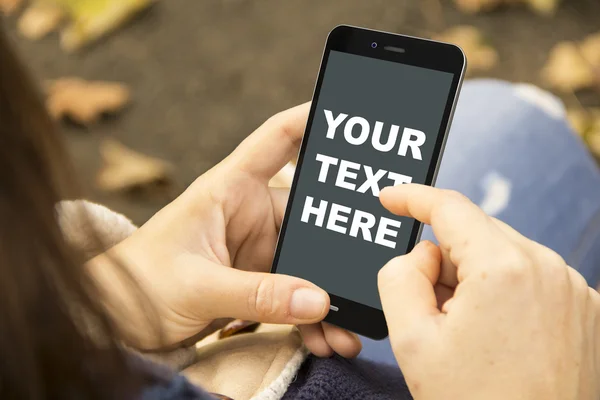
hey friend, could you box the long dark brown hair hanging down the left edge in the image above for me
[0,21,140,399]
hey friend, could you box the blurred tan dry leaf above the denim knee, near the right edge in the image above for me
[542,42,596,92]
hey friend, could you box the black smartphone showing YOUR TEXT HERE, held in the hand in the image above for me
[271,26,466,339]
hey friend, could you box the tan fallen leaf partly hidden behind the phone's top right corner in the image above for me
[435,25,498,71]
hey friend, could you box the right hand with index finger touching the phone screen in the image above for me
[379,185,600,400]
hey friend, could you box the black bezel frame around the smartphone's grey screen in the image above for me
[271,25,466,340]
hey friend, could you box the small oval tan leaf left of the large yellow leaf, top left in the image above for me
[18,0,65,40]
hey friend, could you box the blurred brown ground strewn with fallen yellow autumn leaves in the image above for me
[0,0,600,224]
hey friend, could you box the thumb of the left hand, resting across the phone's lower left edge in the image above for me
[201,266,329,324]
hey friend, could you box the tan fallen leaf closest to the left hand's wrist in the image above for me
[96,139,173,191]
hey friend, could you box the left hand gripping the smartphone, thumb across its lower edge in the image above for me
[90,103,360,357]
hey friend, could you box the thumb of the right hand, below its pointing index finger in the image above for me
[378,241,441,342]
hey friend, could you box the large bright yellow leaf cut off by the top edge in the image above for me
[54,0,153,51]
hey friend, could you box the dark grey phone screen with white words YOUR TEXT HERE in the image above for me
[275,50,454,310]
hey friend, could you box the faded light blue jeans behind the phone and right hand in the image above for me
[360,80,600,365]
